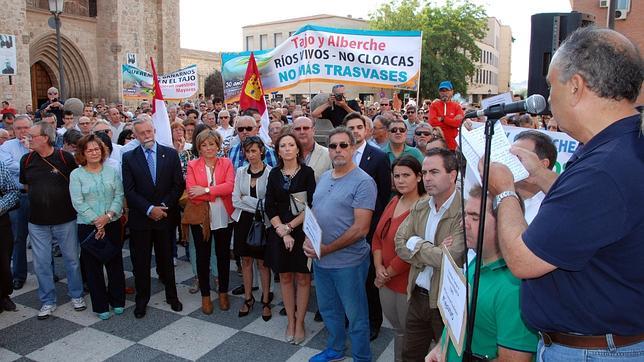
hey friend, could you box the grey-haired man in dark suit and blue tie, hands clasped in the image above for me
[123,120,185,318]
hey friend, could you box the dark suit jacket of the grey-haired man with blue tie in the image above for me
[122,143,186,230]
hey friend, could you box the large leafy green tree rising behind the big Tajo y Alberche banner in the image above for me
[369,0,487,98]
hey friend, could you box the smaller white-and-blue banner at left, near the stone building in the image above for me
[121,64,199,99]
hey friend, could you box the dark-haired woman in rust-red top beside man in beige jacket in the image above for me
[371,155,425,361]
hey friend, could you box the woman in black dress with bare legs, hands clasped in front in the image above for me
[265,133,315,344]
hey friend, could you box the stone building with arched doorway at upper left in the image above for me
[0,0,181,111]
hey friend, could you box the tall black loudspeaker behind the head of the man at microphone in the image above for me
[528,11,595,113]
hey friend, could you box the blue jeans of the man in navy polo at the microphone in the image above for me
[537,334,644,362]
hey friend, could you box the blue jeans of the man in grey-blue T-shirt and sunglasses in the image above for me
[313,255,371,362]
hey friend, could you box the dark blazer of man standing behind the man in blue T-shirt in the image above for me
[360,141,391,242]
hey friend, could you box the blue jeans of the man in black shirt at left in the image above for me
[29,219,83,304]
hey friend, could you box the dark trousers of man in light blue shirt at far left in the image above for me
[9,193,29,282]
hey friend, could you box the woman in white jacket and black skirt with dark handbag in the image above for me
[232,136,272,321]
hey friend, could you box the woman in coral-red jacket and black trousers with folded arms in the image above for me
[186,130,235,314]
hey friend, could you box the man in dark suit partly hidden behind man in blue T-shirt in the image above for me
[344,112,391,341]
